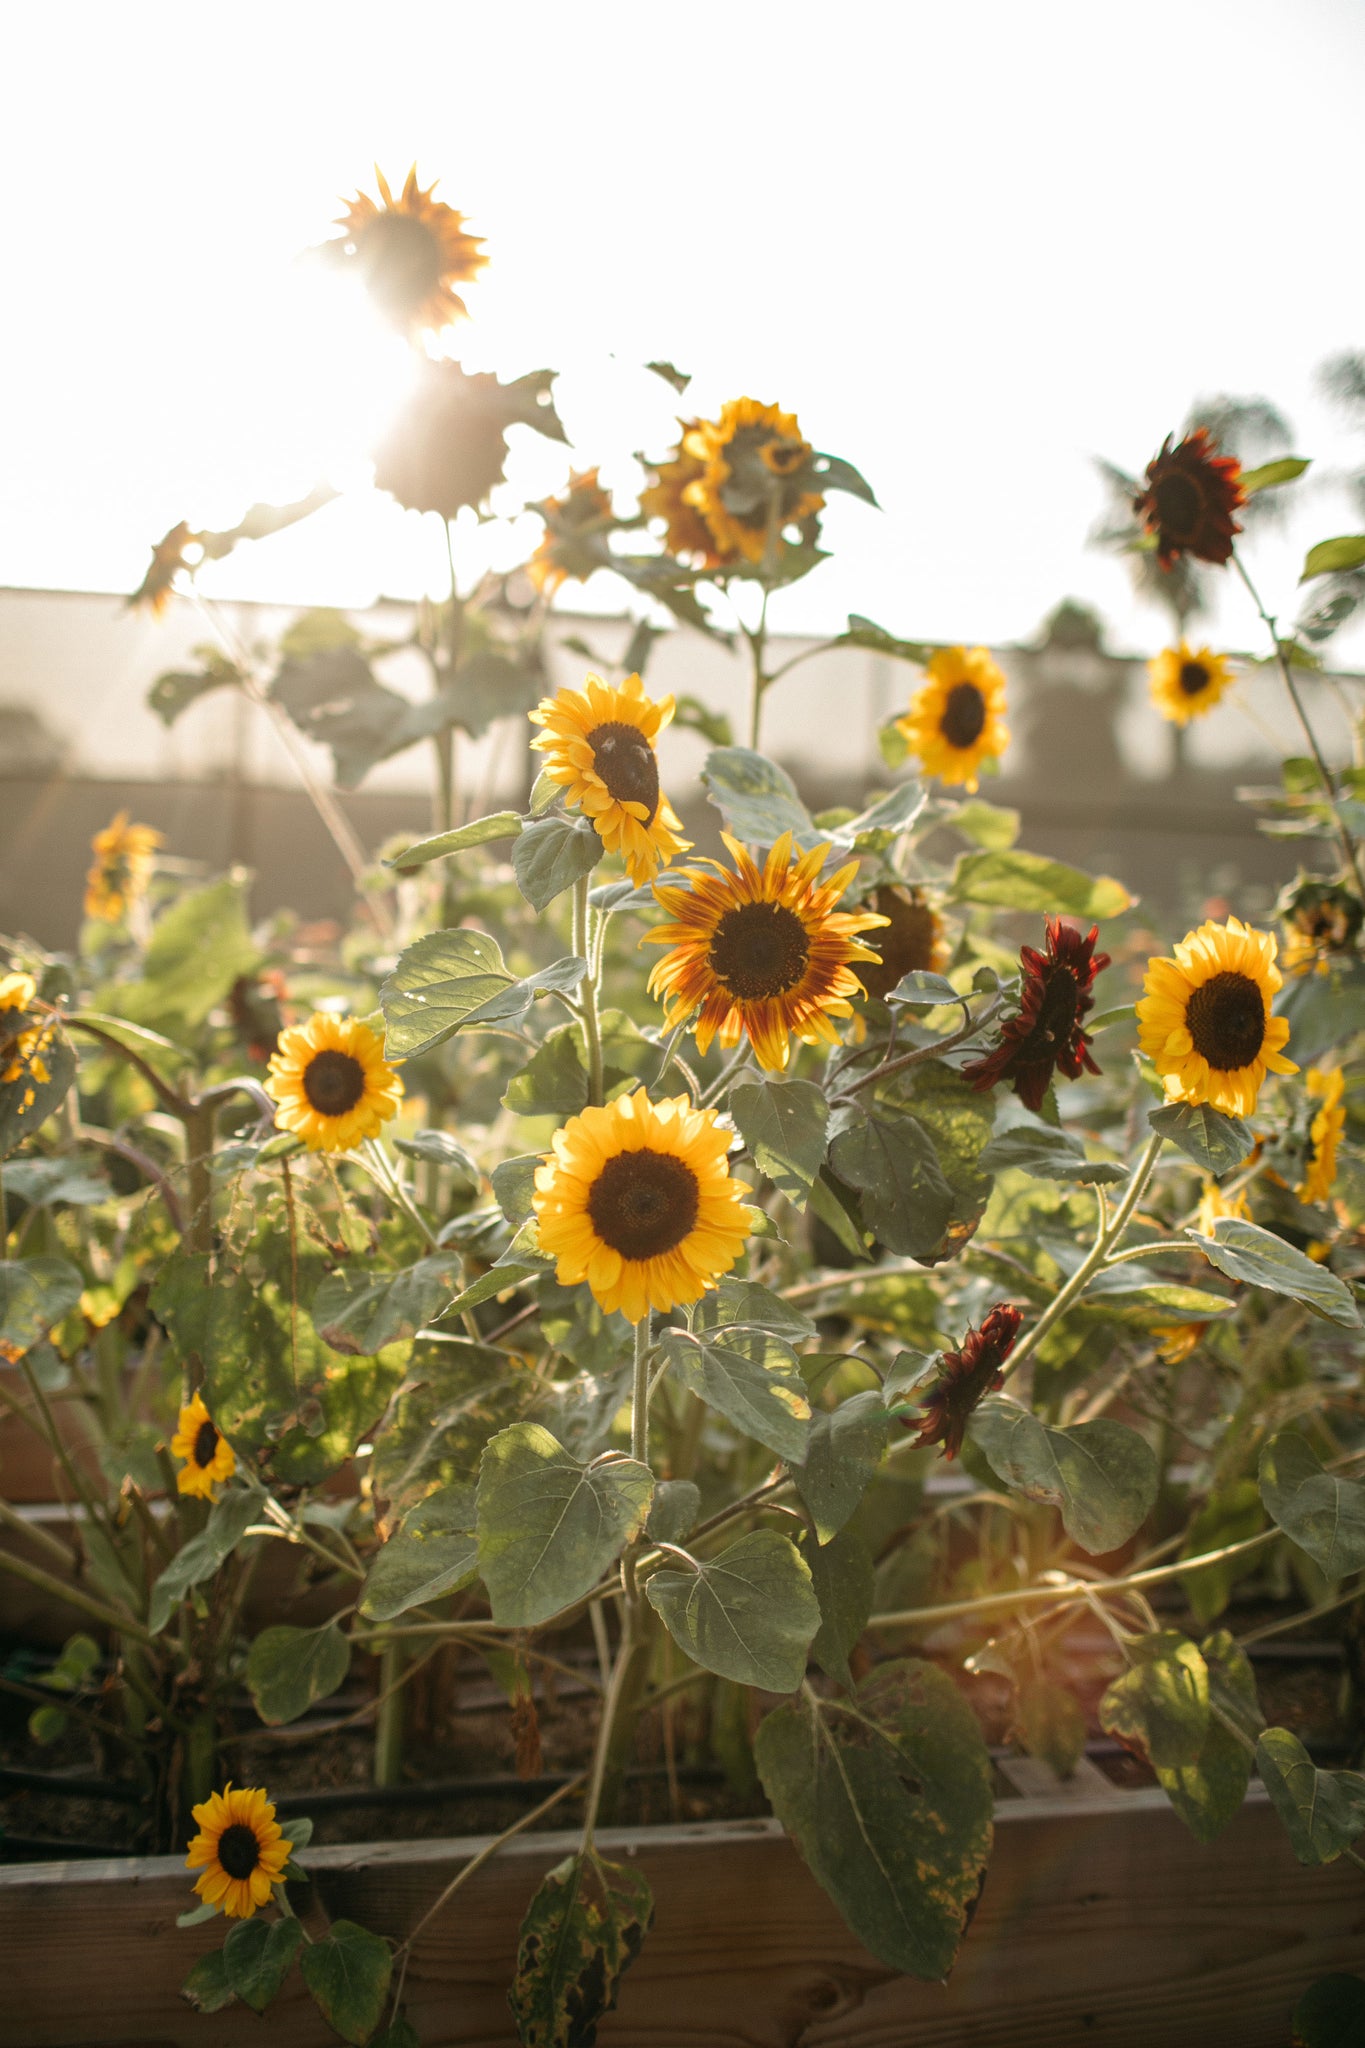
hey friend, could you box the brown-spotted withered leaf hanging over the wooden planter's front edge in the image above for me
[508,1851,655,2048]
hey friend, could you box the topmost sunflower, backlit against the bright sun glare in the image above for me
[325,164,487,334]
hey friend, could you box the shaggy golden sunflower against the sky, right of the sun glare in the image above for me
[681,397,825,561]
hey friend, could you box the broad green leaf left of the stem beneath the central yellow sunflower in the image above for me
[479,1421,655,1628]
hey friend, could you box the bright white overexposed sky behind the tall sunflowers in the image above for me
[0,0,1365,653]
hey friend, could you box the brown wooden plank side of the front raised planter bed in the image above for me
[0,1792,1365,2048]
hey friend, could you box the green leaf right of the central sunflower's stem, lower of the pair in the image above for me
[645,1530,821,1692]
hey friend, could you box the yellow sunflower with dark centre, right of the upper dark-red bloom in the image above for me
[1138,918,1300,1116]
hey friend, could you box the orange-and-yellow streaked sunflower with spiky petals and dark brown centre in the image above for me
[645,831,886,1069]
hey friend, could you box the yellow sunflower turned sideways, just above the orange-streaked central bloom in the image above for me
[530,676,692,887]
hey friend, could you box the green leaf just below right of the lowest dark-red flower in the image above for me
[972,1399,1160,1556]
